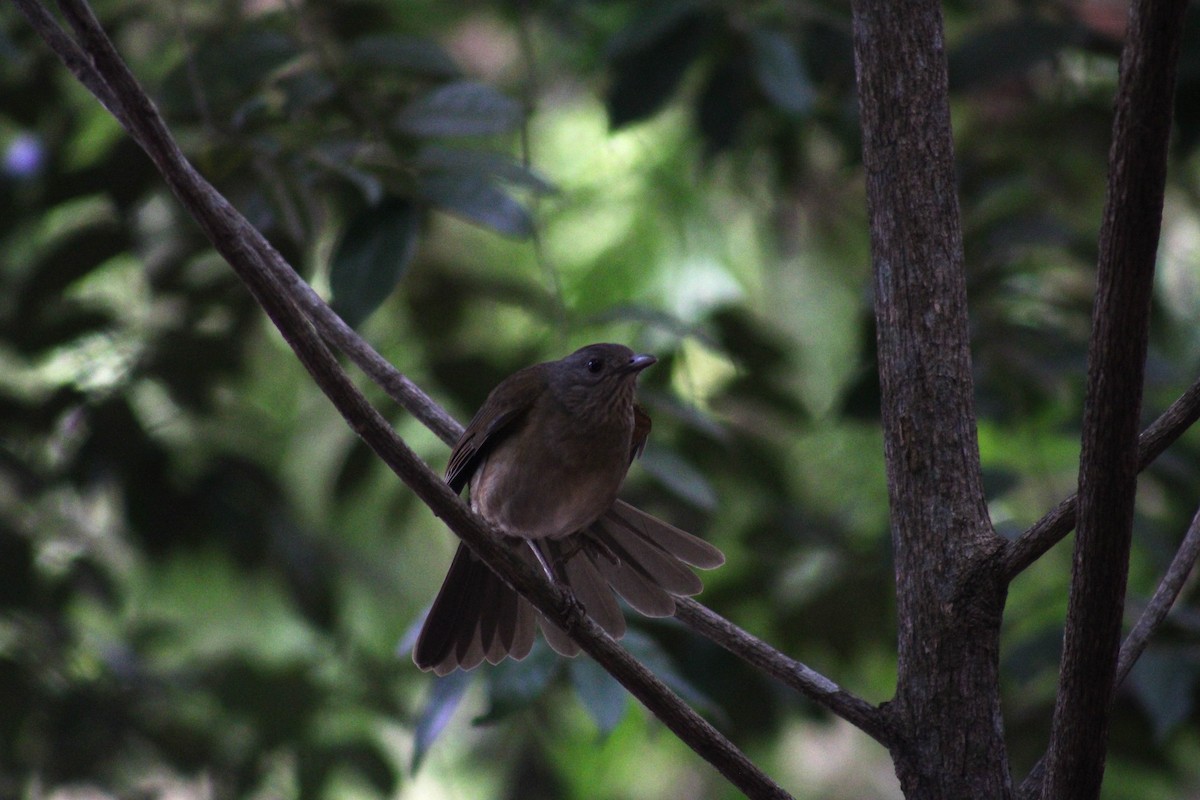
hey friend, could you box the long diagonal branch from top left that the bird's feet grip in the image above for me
[21,0,790,798]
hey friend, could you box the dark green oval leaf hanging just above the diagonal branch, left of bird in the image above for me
[329,197,420,327]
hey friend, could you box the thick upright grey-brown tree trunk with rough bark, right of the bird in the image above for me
[853,0,1012,800]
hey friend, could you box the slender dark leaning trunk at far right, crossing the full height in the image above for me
[1043,0,1187,800]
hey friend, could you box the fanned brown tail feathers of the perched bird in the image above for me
[413,500,725,675]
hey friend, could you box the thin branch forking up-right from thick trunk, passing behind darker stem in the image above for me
[1003,379,1200,582]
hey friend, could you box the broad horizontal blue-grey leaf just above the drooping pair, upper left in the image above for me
[395,80,522,137]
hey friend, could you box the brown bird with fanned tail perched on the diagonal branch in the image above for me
[413,344,725,675]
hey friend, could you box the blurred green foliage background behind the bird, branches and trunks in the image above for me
[0,0,1200,798]
